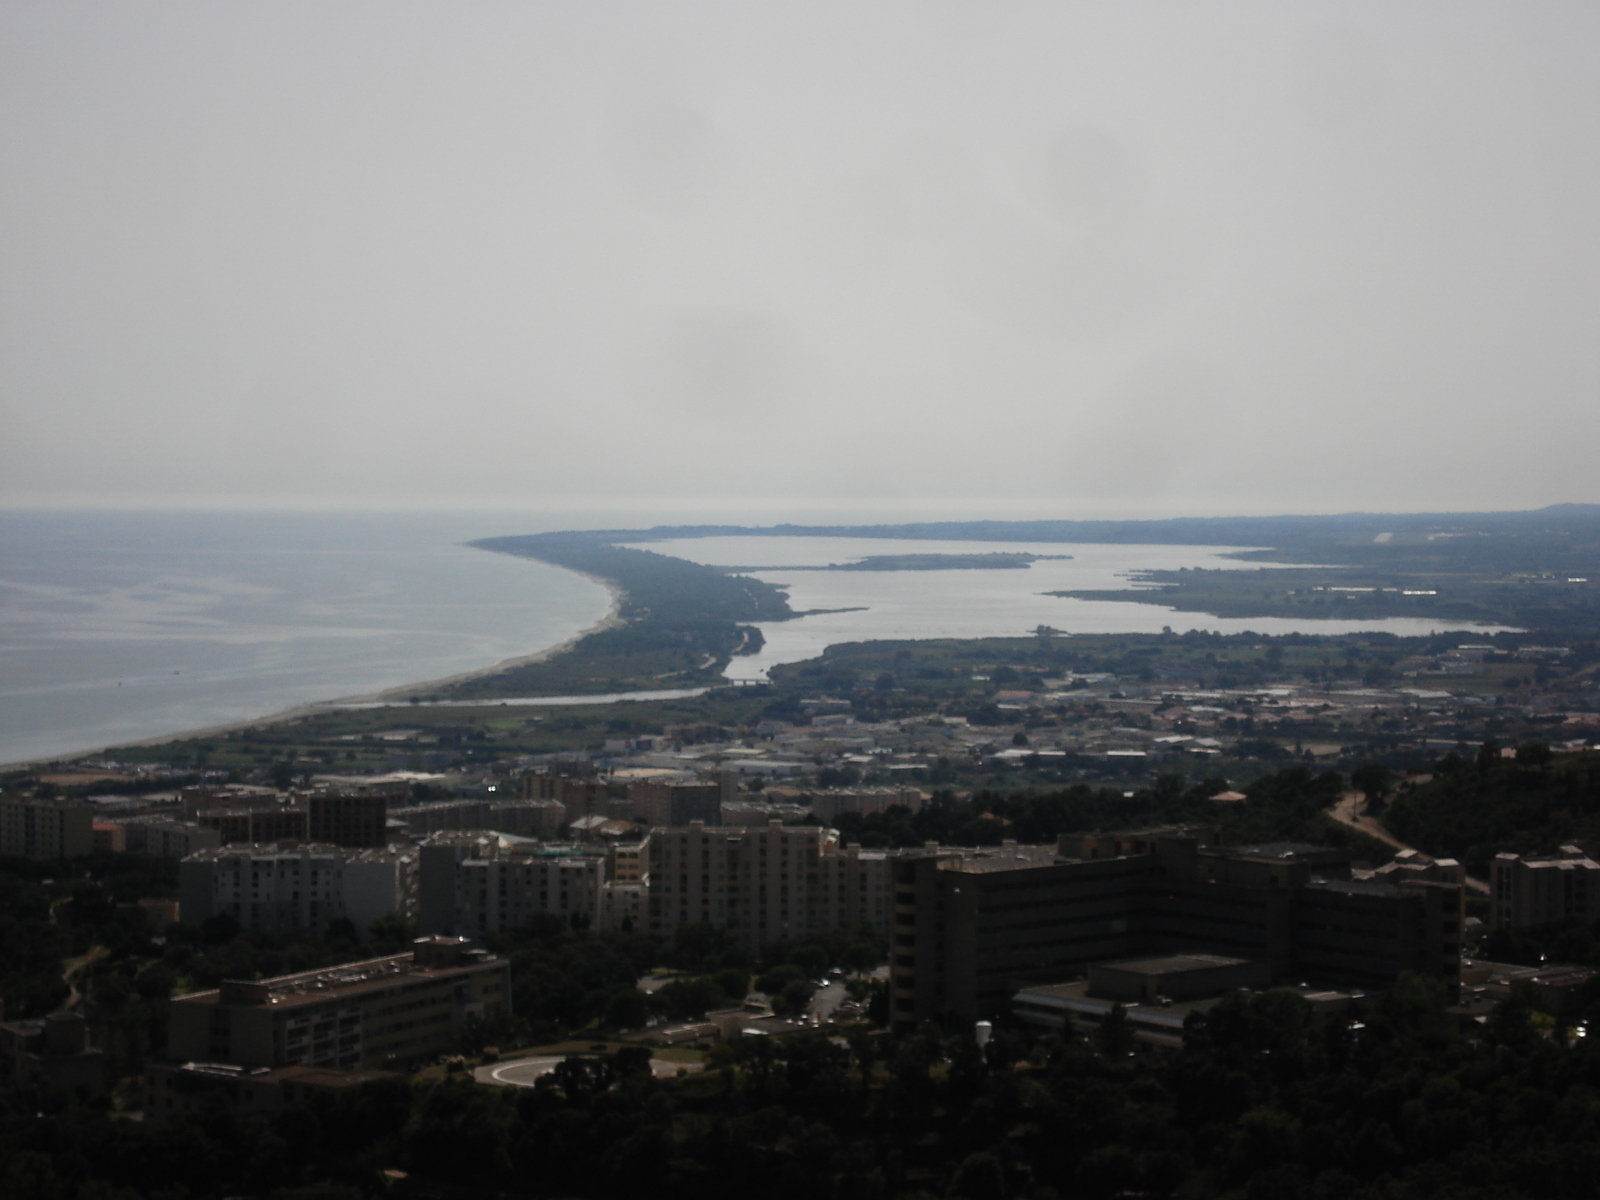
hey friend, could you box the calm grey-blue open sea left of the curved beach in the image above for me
[0,512,610,763]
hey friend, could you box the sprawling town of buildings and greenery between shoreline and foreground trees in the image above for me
[0,537,1600,1200]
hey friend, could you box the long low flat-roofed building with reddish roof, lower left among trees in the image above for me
[166,938,510,1069]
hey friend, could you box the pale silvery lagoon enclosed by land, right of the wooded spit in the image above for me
[624,538,1510,680]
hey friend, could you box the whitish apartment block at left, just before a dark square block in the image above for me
[178,845,416,930]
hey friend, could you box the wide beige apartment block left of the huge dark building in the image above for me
[650,821,890,949]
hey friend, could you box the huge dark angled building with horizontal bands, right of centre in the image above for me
[891,829,1462,1024]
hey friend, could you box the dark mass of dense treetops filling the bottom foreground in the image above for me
[12,976,1600,1200]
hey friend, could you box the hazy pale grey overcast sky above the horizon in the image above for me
[0,0,1600,518]
